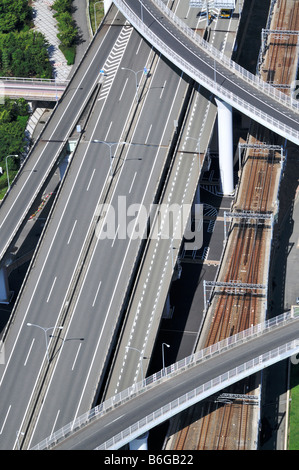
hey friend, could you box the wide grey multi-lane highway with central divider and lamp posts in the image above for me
[0,4,195,449]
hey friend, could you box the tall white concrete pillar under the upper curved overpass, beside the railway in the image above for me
[216,98,234,196]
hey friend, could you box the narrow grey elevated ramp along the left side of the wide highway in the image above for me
[0,16,124,274]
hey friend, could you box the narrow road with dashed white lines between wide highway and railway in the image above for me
[104,2,244,399]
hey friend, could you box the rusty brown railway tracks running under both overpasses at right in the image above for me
[170,0,299,450]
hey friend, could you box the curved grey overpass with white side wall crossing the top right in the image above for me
[114,0,299,144]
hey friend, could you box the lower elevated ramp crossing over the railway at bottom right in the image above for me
[29,309,299,450]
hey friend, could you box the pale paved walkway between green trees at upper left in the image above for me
[32,0,72,80]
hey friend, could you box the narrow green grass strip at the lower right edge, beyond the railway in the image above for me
[289,363,299,450]
